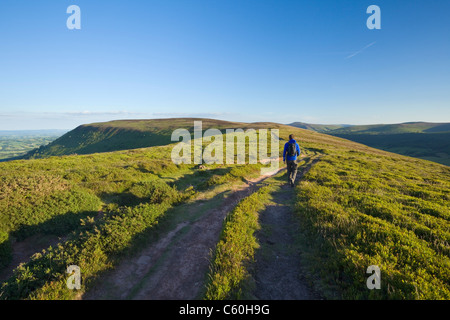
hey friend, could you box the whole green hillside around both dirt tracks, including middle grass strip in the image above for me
[0,119,450,300]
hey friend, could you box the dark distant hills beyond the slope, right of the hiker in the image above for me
[291,122,450,165]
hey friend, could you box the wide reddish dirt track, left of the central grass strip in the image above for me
[82,168,284,300]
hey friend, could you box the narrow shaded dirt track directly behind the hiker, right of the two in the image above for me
[252,159,320,300]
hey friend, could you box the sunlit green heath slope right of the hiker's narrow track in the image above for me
[296,151,450,299]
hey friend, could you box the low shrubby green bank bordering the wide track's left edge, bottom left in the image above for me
[1,203,175,300]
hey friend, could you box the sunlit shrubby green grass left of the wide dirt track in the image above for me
[0,133,280,299]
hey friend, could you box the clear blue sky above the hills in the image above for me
[0,0,450,130]
